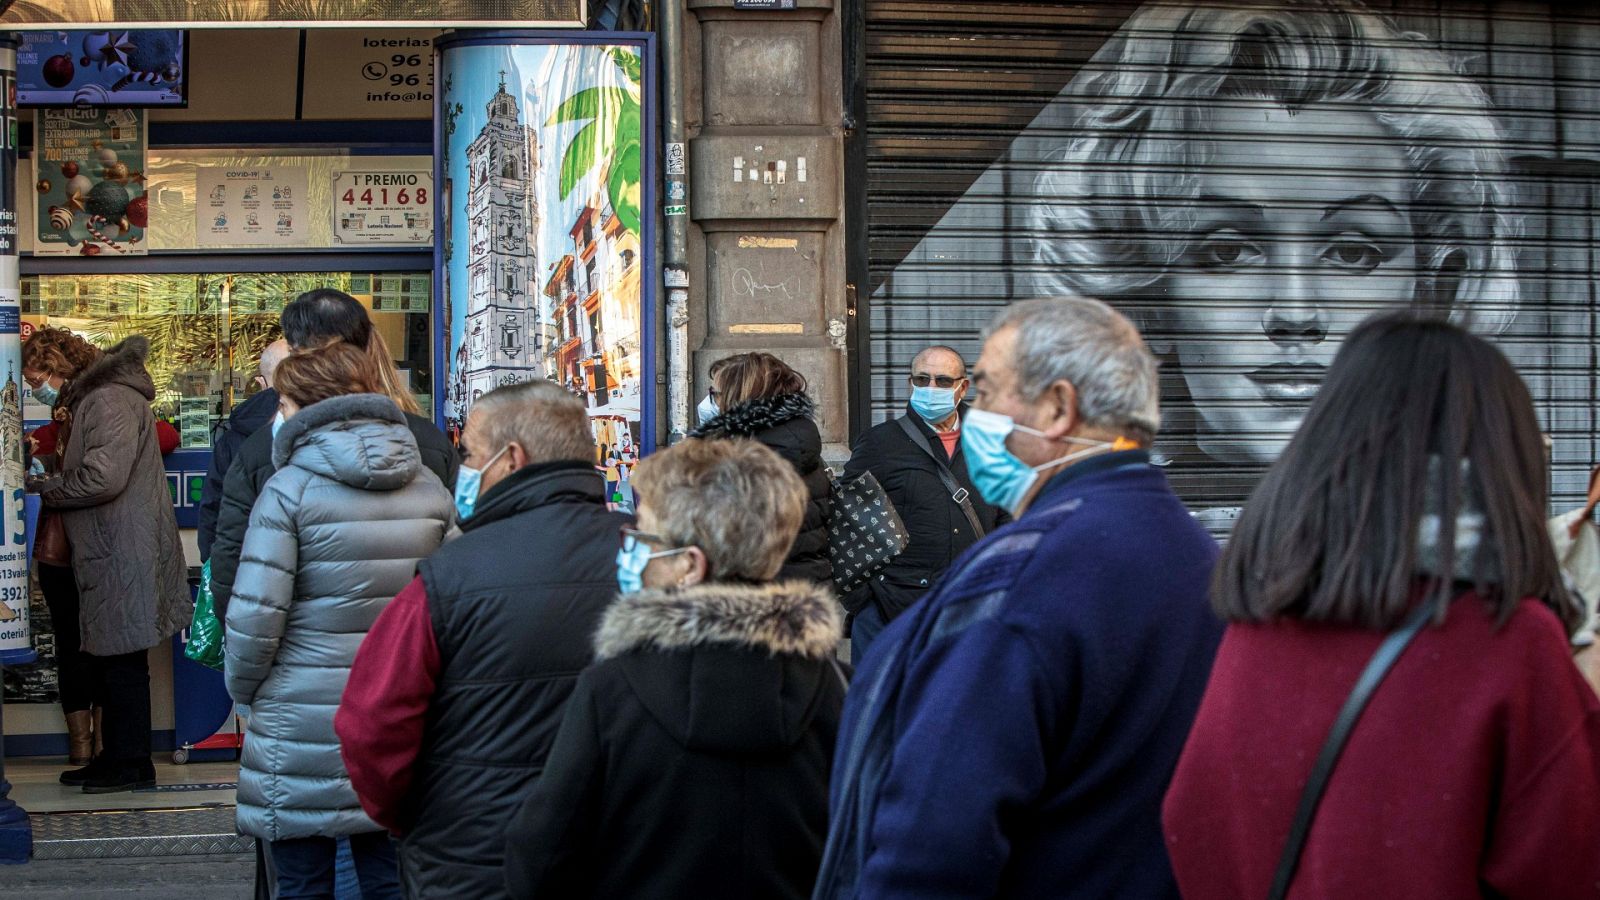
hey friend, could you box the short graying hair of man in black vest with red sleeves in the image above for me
[470,378,595,464]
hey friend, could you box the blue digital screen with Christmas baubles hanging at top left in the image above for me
[16,29,189,106]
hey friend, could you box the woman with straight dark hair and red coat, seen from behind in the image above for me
[1163,314,1600,900]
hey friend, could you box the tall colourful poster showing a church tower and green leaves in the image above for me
[437,43,650,483]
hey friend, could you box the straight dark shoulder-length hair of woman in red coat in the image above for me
[1213,314,1581,631]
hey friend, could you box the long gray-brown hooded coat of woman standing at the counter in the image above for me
[38,336,194,657]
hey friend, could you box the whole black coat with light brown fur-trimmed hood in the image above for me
[506,581,845,900]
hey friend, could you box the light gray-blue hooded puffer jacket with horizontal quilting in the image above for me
[224,394,454,841]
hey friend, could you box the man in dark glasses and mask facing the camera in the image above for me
[845,346,1003,650]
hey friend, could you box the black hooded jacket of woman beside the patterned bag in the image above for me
[691,394,834,585]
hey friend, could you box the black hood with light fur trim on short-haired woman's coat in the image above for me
[594,581,840,754]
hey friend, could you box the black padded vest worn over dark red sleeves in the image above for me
[400,463,634,900]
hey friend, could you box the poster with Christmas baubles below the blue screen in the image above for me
[34,107,150,256]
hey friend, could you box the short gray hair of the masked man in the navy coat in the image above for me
[984,295,1162,439]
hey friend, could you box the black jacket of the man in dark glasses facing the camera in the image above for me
[845,405,1010,621]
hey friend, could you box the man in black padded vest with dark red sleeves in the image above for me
[334,381,634,900]
